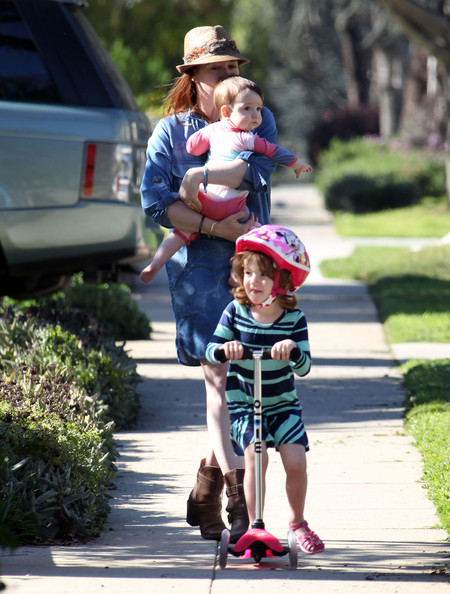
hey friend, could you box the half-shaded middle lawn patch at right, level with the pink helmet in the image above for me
[320,245,450,342]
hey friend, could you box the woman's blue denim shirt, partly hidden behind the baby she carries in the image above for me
[141,107,277,227]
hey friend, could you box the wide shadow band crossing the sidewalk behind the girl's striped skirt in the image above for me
[135,370,404,430]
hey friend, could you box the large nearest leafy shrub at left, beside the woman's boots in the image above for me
[0,322,116,543]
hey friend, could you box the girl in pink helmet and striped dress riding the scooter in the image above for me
[206,225,325,554]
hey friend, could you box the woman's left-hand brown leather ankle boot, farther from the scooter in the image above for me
[186,459,226,540]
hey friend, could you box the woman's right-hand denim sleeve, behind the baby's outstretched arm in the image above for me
[238,107,277,192]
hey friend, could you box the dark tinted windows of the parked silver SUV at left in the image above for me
[0,0,139,111]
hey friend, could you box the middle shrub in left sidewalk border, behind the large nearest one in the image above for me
[0,302,140,429]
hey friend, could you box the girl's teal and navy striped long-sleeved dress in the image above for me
[206,300,311,455]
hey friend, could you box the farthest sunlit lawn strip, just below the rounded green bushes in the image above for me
[334,196,450,238]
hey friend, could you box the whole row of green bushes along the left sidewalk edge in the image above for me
[0,279,151,547]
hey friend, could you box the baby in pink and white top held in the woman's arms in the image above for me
[140,76,312,283]
